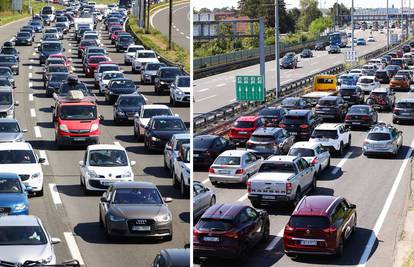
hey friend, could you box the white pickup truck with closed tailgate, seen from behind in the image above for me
[247,156,317,207]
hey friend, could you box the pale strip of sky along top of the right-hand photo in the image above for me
[191,0,414,9]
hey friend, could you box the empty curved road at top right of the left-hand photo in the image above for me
[150,2,190,51]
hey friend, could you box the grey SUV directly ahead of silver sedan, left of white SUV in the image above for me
[246,127,295,157]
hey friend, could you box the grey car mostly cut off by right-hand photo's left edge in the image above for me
[193,181,216,223]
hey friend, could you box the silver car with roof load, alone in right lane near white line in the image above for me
[362,123,403,156]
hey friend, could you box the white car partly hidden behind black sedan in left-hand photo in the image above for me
[134,105,173,140]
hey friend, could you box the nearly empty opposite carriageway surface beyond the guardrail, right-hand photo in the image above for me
[194,30,398,115]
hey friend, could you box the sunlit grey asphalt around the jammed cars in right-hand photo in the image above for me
[194,87,414,266]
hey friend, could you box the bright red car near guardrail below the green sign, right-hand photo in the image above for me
[229,116,264,144]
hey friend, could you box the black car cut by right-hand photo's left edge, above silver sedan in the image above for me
[193,135,236,167]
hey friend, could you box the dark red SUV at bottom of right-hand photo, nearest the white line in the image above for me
[283,196,357,257]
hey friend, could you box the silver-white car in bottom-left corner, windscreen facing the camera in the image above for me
[0,215,60,266]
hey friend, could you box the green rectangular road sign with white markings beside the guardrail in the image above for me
[236,76,265,101]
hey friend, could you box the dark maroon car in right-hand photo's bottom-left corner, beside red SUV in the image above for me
[193,204,270,262]
